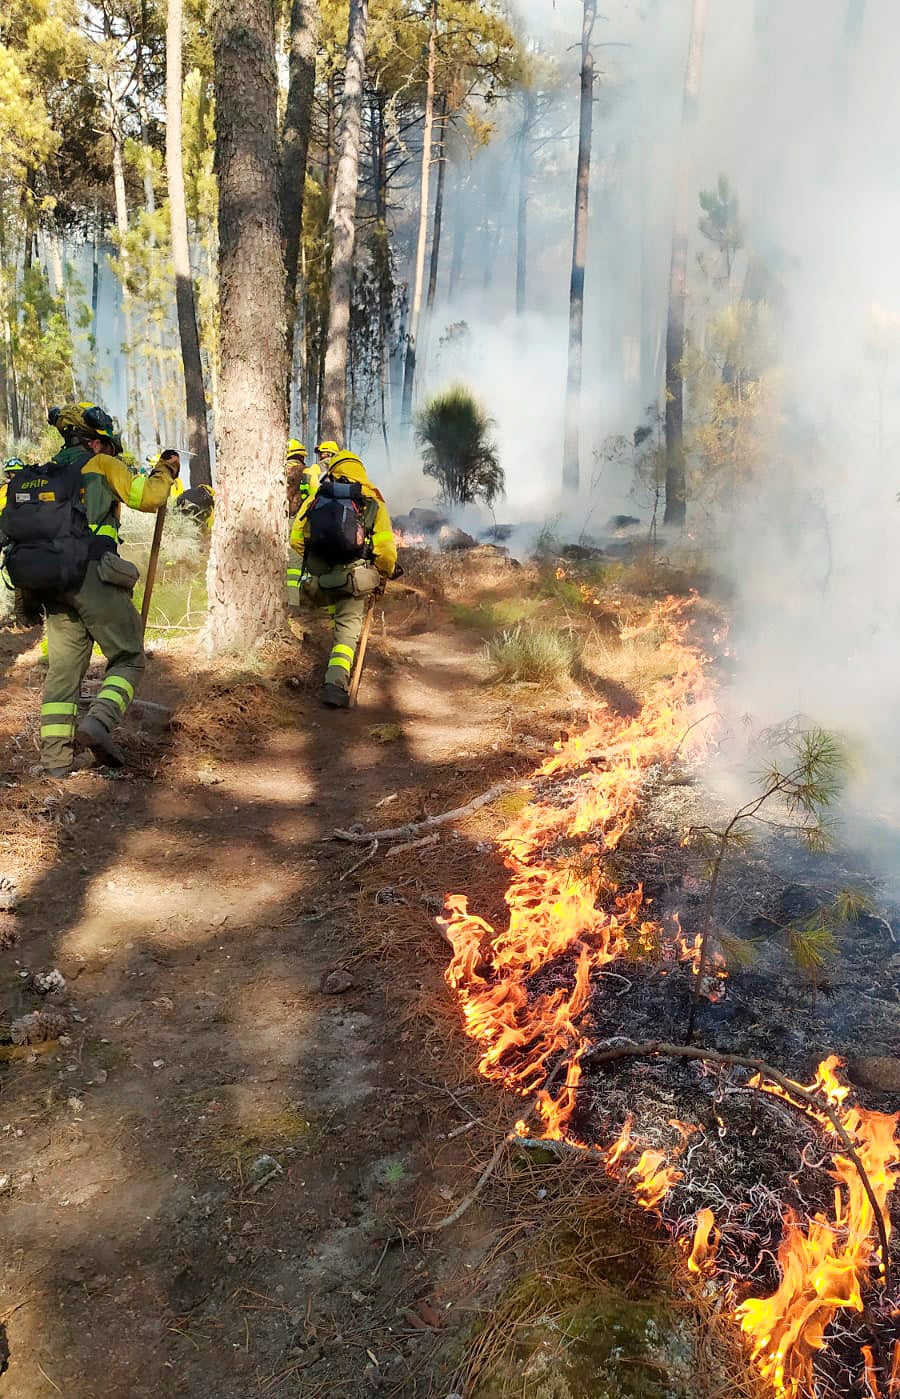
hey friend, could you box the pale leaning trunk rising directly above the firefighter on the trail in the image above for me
[322,0,368,445]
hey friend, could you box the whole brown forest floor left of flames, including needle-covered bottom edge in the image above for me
[0,555,749,1399]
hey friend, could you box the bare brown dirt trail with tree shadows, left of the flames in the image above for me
[0,607,545,1399]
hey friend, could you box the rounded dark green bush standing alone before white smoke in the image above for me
[416,383,505,505]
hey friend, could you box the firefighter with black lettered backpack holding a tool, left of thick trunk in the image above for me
[0,403,176,778]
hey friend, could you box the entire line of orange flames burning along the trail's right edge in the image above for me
[444,599,900,1399]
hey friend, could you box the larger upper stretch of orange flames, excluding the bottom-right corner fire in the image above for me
[442,599,708,1133]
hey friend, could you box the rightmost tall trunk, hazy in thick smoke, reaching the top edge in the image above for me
[662,0,708,525]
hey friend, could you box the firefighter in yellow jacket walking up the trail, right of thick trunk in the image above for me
[291,452,398,709]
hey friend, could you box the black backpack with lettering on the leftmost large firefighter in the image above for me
[0,452,92,600]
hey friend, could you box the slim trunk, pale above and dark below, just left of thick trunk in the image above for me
[165,0,213,485]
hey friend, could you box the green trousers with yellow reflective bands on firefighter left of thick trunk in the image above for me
[41,562,146,769]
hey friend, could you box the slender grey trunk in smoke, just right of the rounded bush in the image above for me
[563,0,596,491]
